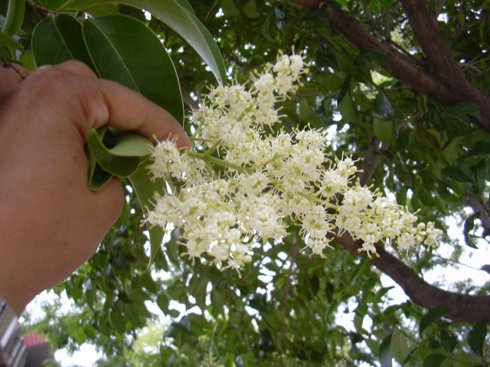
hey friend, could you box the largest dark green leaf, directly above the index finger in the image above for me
[82,15,184,123]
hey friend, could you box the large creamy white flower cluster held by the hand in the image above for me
[147,54,441,268]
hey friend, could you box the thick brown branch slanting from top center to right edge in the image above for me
[296,0,490,131]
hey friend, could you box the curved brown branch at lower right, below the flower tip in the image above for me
[336,234,490,323]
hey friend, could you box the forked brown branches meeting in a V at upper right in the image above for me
[296,0,490,132]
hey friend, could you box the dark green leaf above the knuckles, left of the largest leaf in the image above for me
[31,14,93,68]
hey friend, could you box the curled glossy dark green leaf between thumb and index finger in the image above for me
[87,129,140,177]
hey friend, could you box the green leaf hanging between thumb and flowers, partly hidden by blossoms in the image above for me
[129,158,165,258]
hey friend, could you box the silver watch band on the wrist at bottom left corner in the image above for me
[0,296,27,367]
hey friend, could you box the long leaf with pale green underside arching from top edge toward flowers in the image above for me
[60,0,226,83]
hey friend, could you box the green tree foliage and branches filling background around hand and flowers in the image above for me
[0,0,490,367]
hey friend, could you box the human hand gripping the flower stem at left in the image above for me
[0,61,190,314]
